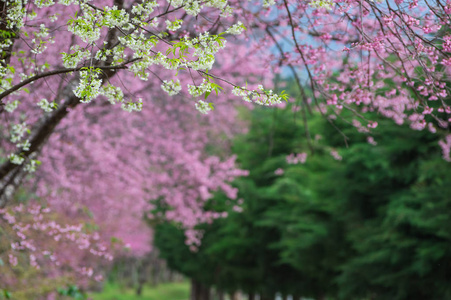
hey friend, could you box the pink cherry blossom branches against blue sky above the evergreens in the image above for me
[230,0,451,155]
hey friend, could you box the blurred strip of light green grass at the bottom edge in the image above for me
[89,281,190,300]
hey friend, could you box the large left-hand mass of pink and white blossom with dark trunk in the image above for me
[0,1,264,290]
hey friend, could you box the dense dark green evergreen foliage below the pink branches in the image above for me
[156,98,451,300]
